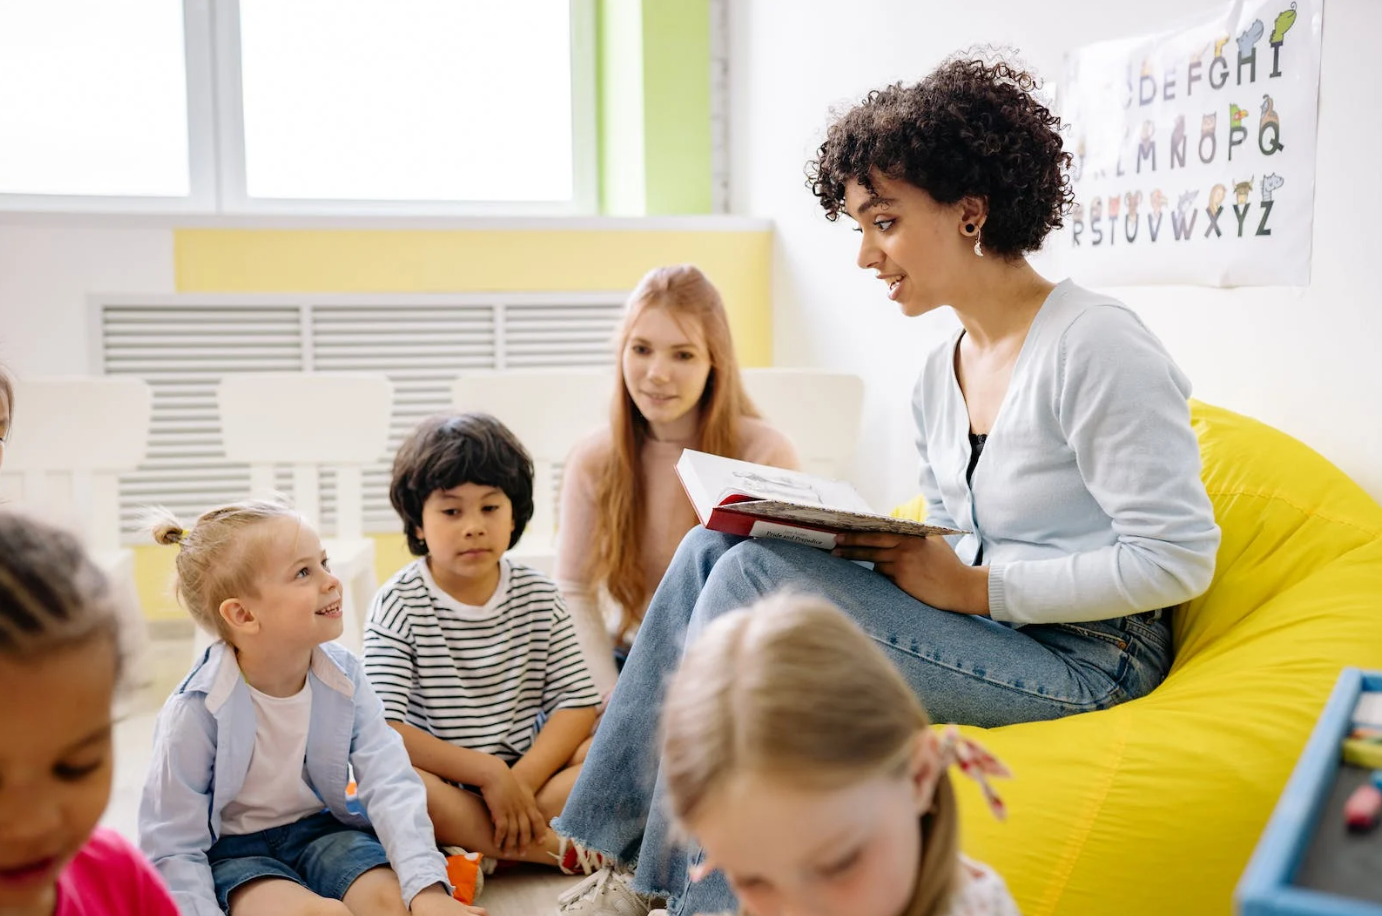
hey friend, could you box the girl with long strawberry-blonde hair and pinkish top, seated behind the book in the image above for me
[556,264,797,692]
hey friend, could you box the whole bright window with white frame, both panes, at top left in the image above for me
[0,0,596,216]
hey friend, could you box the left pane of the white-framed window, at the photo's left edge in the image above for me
[0,0,210,210]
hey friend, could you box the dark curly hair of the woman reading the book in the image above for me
[806,54,1075,257]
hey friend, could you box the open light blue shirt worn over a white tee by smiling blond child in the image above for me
[140,642,451,916]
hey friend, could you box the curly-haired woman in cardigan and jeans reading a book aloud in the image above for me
[556,57,1219,916]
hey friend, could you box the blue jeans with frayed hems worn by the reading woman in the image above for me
[554,528,1171,916]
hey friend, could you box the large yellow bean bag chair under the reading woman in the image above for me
[898,402,1382,916]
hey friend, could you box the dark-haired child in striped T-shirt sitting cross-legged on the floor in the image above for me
[365,413,603,873]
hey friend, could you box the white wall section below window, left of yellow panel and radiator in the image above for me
[0,221,173,376]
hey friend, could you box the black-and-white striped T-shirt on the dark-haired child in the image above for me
[365,558,600,764]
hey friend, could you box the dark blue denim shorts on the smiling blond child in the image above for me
[206,811,388,913]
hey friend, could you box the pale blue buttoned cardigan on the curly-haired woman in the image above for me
[912,280,1219,624]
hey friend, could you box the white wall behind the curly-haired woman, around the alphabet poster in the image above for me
[730,0,1382,508]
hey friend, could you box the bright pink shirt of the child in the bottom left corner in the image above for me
[54,828,178,916]
